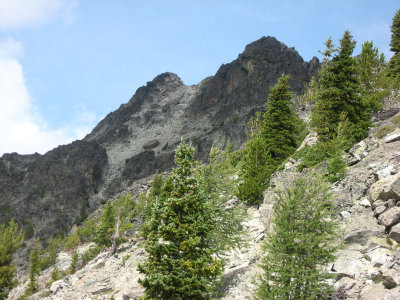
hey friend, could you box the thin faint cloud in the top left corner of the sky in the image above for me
[0,0,75,30]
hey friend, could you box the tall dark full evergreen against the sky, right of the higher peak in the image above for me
[311,31,369,141]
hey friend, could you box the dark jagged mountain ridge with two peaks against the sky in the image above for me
[0,37,319,237]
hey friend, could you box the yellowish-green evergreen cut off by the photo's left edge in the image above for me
[0,220,24,300]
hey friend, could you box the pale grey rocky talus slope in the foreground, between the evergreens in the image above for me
[10,96,400,300]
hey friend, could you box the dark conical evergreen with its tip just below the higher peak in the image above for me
[260,75,298,165]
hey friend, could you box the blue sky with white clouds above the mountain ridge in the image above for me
[0,0,400,155]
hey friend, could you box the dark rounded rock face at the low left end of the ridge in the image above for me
[0,141,108,237]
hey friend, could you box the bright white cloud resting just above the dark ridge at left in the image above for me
[0,38,99,155]
